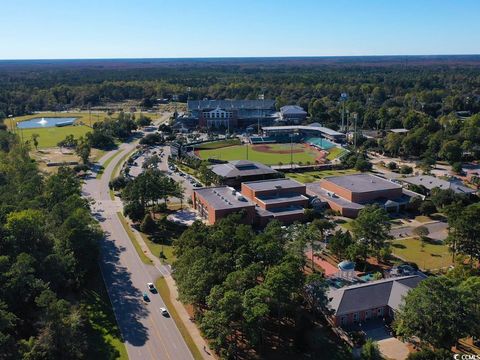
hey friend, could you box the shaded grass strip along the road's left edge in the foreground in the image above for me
[81,268,128,360]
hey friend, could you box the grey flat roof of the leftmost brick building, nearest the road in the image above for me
[193,186,255,210]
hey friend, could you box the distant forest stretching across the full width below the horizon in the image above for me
[0,62,480,129]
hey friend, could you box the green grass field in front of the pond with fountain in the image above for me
[16,125,92,149]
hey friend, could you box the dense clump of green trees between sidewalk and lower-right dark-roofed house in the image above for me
[173,214,340,358]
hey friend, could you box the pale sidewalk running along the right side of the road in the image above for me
[127,215,217,360]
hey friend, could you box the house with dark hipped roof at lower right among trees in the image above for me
[327,275,423,326]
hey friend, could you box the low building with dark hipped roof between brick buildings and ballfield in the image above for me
[209,160,282,188]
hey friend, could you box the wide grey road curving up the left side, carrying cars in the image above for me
[83,122,193,360]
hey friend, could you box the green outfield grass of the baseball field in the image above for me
[198,144,320,165]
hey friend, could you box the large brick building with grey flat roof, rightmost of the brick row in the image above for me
[306,173,421,218]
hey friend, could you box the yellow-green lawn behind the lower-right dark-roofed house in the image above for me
[392,237,452,270]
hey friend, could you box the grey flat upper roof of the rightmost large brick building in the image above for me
[322,174,402,193]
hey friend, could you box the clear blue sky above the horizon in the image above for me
[0,0,480,59]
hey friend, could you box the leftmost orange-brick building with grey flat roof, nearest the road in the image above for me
[192,186,255,225]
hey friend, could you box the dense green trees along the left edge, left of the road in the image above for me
[0,131,106,360]
